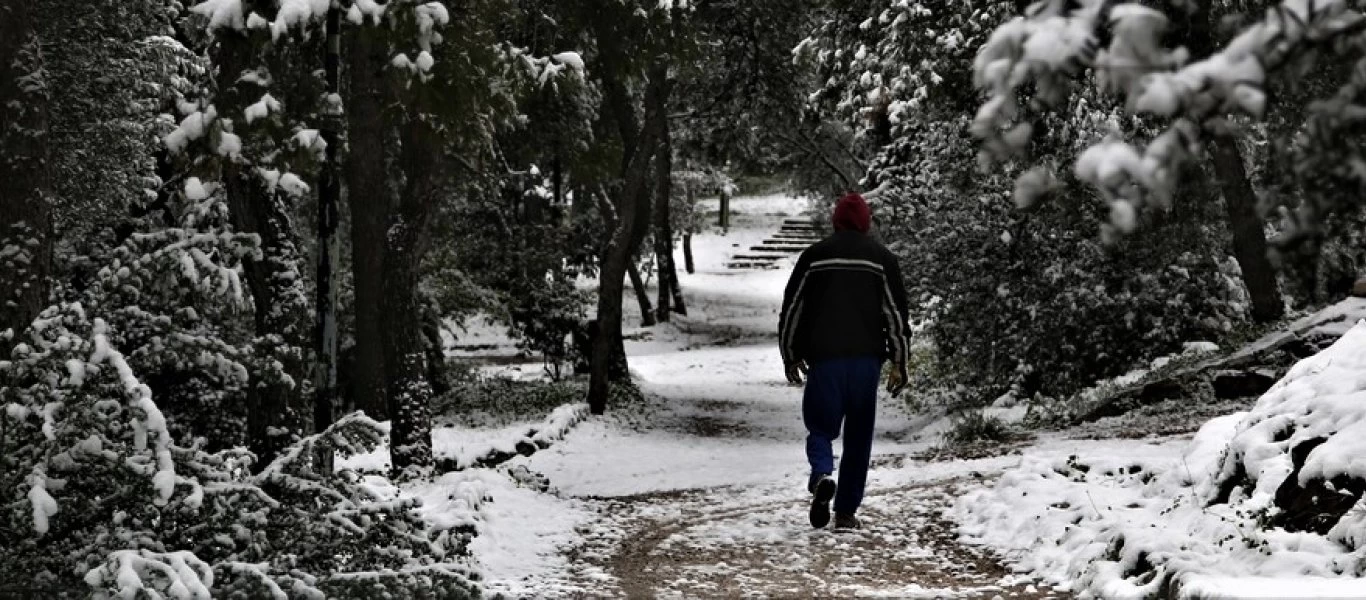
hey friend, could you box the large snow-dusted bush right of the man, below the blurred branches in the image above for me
[869,118,1243,405]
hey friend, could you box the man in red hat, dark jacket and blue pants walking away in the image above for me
[779,194,908,529]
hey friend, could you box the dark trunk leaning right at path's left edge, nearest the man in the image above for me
[589,63,668,414]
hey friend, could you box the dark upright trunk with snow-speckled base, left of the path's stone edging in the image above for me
[381,119,441,477]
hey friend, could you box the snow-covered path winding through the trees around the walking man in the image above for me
[474,197,1053,597]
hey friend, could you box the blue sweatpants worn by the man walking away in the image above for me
[802,357,882,514]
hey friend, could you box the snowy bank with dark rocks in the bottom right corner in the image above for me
[953,323,1366,599]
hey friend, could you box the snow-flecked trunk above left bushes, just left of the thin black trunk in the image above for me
[216,29,310,469]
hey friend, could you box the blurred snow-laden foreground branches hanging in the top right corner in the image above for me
[973,0,1366,255]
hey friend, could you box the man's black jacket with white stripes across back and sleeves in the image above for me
[777,231,910,374]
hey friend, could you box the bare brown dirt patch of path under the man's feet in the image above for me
[607,481,1063,599]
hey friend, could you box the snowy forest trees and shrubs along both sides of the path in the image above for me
[0,0,1366,597]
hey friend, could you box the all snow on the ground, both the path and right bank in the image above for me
[344,197,1366,597]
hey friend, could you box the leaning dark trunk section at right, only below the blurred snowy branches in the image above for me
[1209,134,1285,323]
